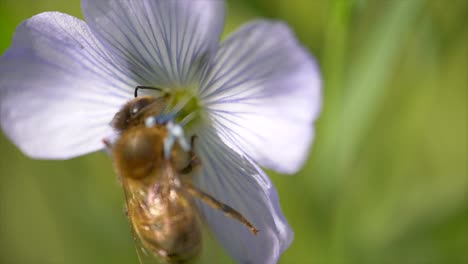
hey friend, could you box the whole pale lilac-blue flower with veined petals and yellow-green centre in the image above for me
[0,0,321,263]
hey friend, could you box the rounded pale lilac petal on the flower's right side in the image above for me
[200,21,321,173]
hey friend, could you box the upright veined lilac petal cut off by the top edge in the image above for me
[82,0,225,87]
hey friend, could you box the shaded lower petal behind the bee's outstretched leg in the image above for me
[195,129,293,264]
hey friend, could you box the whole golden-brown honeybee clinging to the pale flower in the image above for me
[104,86,258,263]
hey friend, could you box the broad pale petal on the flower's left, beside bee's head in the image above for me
[0,12,135,159]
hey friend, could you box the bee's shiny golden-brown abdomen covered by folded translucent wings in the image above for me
[122,162,201,264]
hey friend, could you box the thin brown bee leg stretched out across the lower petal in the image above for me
[184,182,259,235]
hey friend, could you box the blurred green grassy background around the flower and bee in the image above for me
[0,0,468,264]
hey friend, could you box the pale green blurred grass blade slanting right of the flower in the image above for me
[337,0,423,170]
